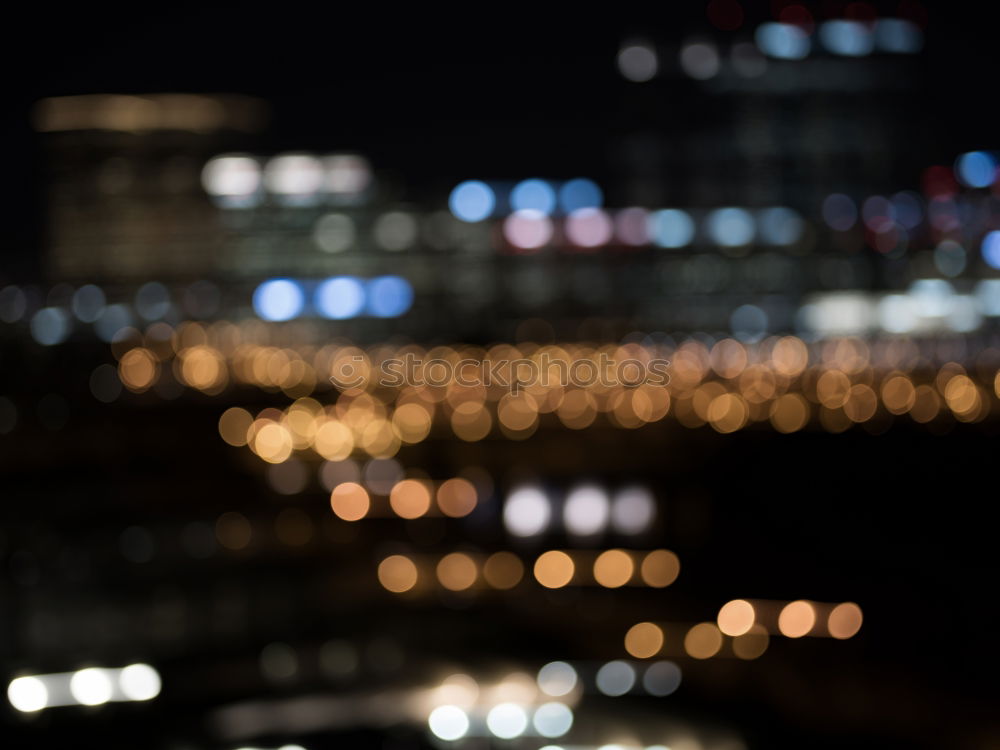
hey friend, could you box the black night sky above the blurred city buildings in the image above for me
[0,1,1000,277]
